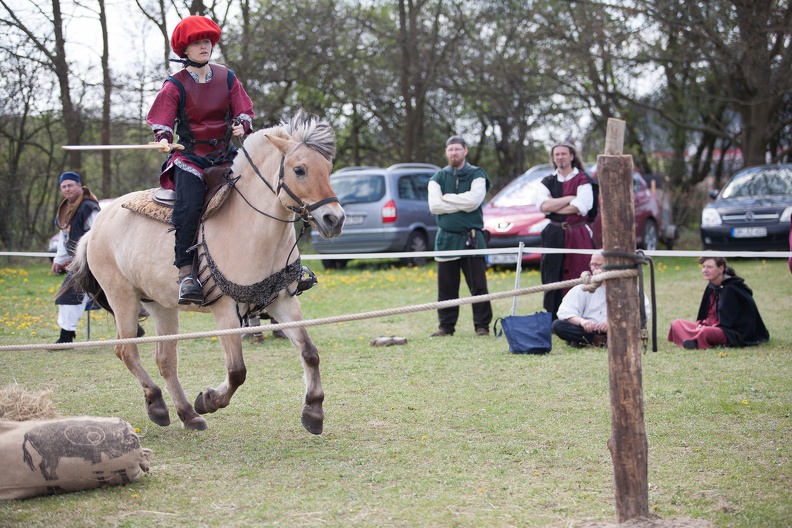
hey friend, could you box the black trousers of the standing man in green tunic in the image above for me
[437,257,492,332]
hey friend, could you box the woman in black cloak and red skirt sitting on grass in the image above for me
[668,257,770,349]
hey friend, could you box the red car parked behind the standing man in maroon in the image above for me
[484,163,676,265]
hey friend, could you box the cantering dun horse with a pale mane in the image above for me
[65,111,344,434]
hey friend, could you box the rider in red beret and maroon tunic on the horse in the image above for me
[146,16,253,304]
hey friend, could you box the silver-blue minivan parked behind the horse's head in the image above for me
[311,163,440,269]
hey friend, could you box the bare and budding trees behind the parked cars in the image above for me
[0,0,792,249]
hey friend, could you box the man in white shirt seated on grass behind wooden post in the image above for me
[553,252,652,348]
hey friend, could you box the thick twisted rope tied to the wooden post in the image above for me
[0,269,638,352]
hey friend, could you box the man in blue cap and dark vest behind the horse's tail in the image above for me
[52,172,99,343]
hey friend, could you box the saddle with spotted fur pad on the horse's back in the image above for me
[121,163,231,224]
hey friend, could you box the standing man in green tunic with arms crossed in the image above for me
[429,136,492,337]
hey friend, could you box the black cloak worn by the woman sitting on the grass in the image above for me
[697,275,770,346]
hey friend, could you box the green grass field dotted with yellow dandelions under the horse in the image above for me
[0,258,792,527]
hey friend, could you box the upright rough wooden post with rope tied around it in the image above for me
[597,119,649,523]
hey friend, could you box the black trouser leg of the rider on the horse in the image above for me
[173,167,206,268]
